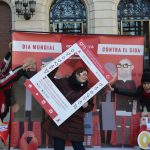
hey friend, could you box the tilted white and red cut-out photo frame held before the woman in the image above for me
[25,39,111,126]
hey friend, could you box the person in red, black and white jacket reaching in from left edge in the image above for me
[0,52,35,122]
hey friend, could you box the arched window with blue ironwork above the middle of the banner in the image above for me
[50,0,86,33]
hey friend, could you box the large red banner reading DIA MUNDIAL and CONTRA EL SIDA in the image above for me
[11,32,144,149]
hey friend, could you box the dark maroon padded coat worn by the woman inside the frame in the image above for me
[44,72,94,141]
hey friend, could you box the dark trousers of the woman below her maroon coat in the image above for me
[54,137,85,150]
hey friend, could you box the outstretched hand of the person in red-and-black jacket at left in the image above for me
[22,58,36,71]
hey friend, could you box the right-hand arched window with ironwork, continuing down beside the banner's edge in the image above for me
[118,0,150,67]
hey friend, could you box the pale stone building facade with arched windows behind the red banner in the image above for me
[0,0,150,67]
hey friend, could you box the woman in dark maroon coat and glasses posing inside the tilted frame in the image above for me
[44,67,94,150]
